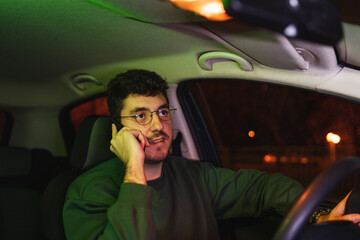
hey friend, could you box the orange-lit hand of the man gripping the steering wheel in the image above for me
[317,193,360,226]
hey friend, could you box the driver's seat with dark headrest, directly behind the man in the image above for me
[39,115,115,240]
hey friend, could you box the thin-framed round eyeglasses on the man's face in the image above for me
[120,107,176,125]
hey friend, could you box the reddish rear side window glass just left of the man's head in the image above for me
[70,96,110,131]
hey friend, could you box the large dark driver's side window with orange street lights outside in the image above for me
[190,80,360,202]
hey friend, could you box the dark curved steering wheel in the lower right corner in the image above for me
[274,157,360,240]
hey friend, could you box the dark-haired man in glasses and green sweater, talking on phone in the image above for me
[63,70,360,240]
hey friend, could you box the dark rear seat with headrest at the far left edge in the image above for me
[0,147,57,240]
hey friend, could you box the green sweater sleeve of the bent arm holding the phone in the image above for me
[63,173,155,240]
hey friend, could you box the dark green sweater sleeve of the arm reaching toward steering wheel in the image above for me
[201,164,303,219]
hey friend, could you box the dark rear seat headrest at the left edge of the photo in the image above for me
[0,147,32,177]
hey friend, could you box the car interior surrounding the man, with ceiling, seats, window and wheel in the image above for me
[0,0,360,240]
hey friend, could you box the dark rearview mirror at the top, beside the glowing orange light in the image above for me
[222,0,343,45]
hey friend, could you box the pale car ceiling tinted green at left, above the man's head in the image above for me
[0,0,360,106]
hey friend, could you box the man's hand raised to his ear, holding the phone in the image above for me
[110,124,149,185]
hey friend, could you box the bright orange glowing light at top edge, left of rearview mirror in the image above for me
[170,0,231,21]
